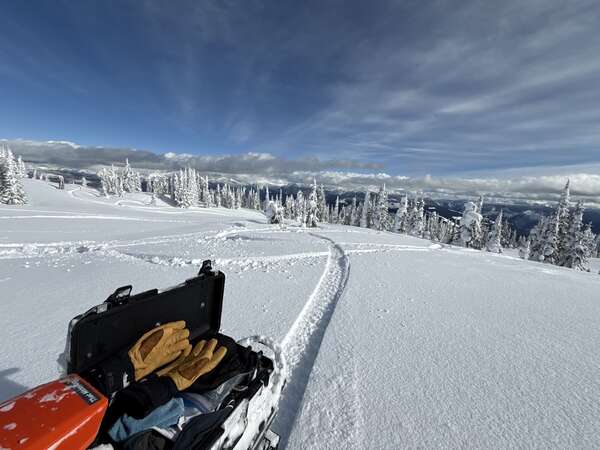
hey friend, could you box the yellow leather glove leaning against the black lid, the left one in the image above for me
[129,320,191,381]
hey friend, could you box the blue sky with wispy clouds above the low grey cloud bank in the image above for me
[0,0,600,176]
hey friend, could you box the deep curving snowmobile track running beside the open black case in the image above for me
[275,233,350,448]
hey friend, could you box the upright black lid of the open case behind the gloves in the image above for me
[67,267,225,373]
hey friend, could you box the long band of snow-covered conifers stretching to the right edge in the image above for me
[92,161,600,270]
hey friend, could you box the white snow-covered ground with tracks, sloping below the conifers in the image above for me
[0,180,600,449]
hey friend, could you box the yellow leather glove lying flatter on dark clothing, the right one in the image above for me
[164,339,227,391]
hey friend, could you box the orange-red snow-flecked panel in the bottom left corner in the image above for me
[0,375,108,450]
